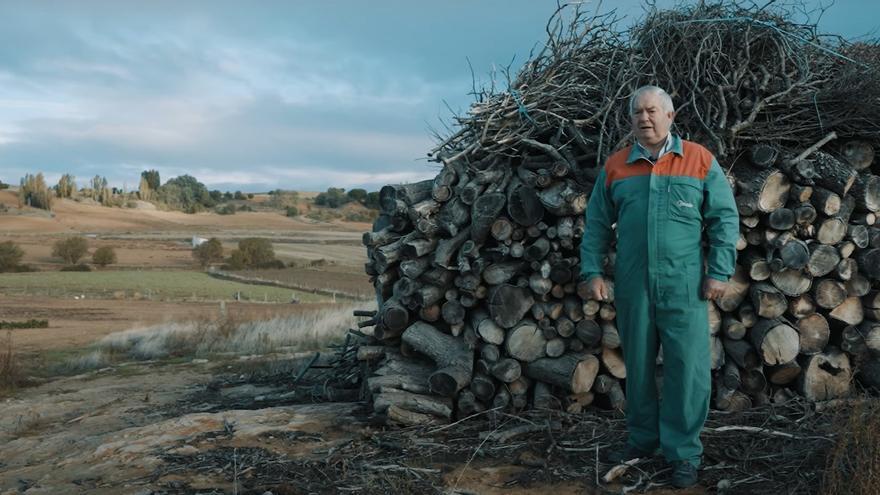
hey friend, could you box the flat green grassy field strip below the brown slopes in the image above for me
[0,271,328,302]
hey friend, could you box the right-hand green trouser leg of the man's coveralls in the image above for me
[656,301,711,466]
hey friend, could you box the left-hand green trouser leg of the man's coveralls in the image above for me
[616,292,660,451]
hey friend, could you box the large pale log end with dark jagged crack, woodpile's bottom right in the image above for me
[797,347,852,402]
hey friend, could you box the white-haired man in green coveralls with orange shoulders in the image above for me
[581,86,739,488]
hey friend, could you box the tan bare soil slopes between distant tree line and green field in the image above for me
[0,191,370,271]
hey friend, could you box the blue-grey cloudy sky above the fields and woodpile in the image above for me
[0,0,880,191]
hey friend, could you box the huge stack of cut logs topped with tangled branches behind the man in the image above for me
[359,4,880,424]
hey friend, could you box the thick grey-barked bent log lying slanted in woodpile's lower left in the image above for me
[403,321,474,397]
